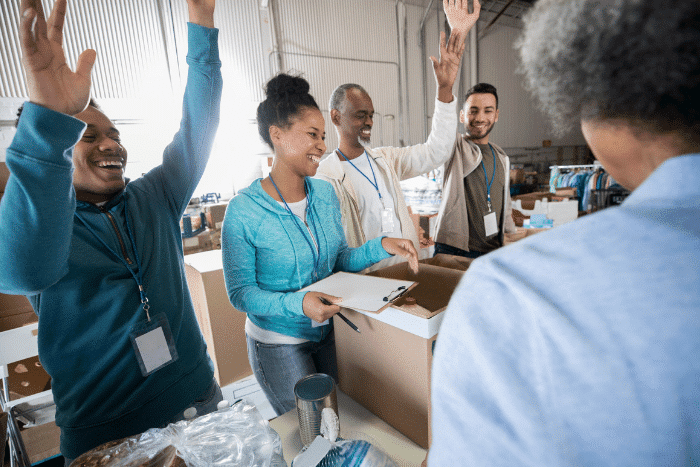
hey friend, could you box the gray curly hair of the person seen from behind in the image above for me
[516,0,700,148]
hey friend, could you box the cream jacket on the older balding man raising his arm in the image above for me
[316,98,457,263]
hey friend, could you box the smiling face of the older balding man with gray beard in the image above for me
[331,88,374,148]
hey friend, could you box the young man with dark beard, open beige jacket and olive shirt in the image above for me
[435,83,515,258]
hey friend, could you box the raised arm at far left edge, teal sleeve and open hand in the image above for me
[0,0,96,295]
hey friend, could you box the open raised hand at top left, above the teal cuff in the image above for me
[20,0,97,115]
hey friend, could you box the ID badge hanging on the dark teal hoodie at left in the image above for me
[129,313,177,376]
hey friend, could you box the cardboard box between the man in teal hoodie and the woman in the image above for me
[185,250,253,387]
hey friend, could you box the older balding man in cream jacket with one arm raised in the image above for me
[316,0,481,269]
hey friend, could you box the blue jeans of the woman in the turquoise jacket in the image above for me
[246,330,338,415]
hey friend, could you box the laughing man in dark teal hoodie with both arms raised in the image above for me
[0,0,222,459]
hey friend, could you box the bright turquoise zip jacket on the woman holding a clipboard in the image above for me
[221,178,391,342]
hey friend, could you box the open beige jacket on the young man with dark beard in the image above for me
[435,135,516,251]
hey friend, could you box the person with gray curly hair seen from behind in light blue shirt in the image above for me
[428,0,700,467]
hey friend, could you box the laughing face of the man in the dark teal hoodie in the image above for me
[73,106,126,203]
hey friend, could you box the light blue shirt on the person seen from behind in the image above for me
[429,154,700,467]
